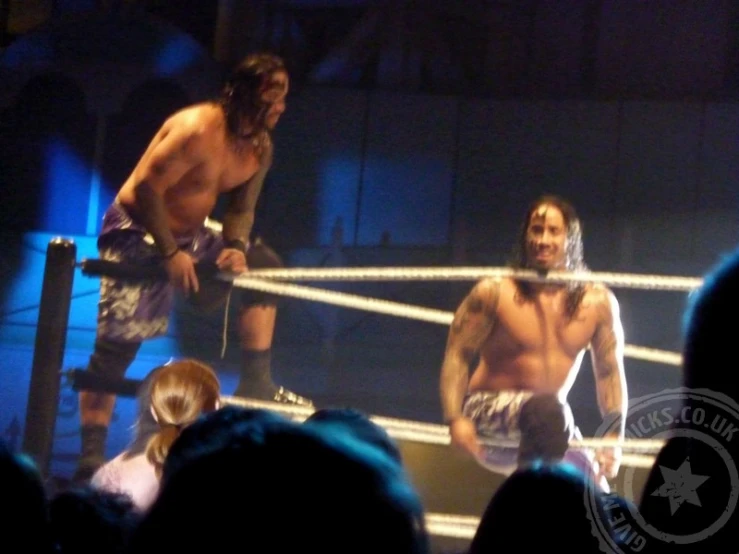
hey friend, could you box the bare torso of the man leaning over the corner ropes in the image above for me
[117,103,260,235]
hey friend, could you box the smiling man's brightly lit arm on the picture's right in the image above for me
[590,288,628,478]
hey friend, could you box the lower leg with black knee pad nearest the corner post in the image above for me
[73,337,141,482]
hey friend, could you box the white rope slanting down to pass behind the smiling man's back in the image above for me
[228,276,682,366]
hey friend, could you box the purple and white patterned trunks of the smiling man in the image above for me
[463,390,589,475]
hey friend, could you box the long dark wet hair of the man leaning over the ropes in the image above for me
[219,52,287,138]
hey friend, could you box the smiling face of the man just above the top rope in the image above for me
[526,204,567,270]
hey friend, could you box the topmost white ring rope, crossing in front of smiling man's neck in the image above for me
[238,267,703,291]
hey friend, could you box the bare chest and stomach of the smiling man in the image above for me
[469,279,599,399]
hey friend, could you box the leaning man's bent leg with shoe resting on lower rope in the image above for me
[234,240,312,405]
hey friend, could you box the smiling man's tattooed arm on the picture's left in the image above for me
[440,279,500,454]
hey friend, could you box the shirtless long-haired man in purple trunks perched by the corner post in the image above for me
[76,53,311,480]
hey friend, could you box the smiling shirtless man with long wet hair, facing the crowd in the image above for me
[440,195,627,487]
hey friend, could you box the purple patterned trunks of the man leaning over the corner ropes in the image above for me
[97,202,223,342]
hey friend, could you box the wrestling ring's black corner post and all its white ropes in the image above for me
[23,238,702,539]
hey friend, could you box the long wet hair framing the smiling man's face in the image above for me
[508,194,588,318]
